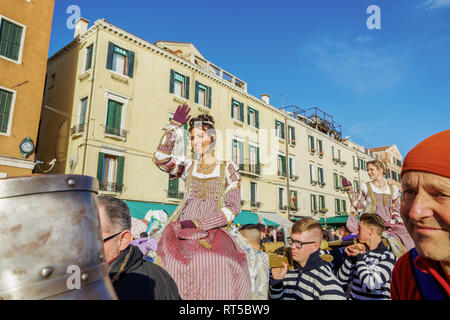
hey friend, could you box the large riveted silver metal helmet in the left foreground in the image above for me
[0,175,117,300]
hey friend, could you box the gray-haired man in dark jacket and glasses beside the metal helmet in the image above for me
[98,195,180,300]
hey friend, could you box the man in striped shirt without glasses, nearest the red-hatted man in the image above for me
[337,213,396,300]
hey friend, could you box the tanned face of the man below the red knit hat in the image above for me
[400,171,450,261]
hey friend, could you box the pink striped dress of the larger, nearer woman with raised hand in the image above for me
[151,123,251,300]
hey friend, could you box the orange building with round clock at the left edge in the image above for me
[0,0,54,178]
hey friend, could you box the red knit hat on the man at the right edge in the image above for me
[401,130,450,179]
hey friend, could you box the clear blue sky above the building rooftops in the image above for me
[49,0,450,156]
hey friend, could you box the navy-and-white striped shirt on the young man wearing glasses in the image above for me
[269,251,345,300]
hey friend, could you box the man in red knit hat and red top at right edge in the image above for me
[391,130,450,300]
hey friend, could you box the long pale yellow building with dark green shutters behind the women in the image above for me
[37,19,384,228]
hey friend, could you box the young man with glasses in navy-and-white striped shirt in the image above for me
[269,218,345,300]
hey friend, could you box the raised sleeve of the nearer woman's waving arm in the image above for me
[153,122,192,179]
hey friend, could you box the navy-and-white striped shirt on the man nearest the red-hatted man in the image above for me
[337,241,396,300]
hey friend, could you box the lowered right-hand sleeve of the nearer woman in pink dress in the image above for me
[197,161,241,230]
